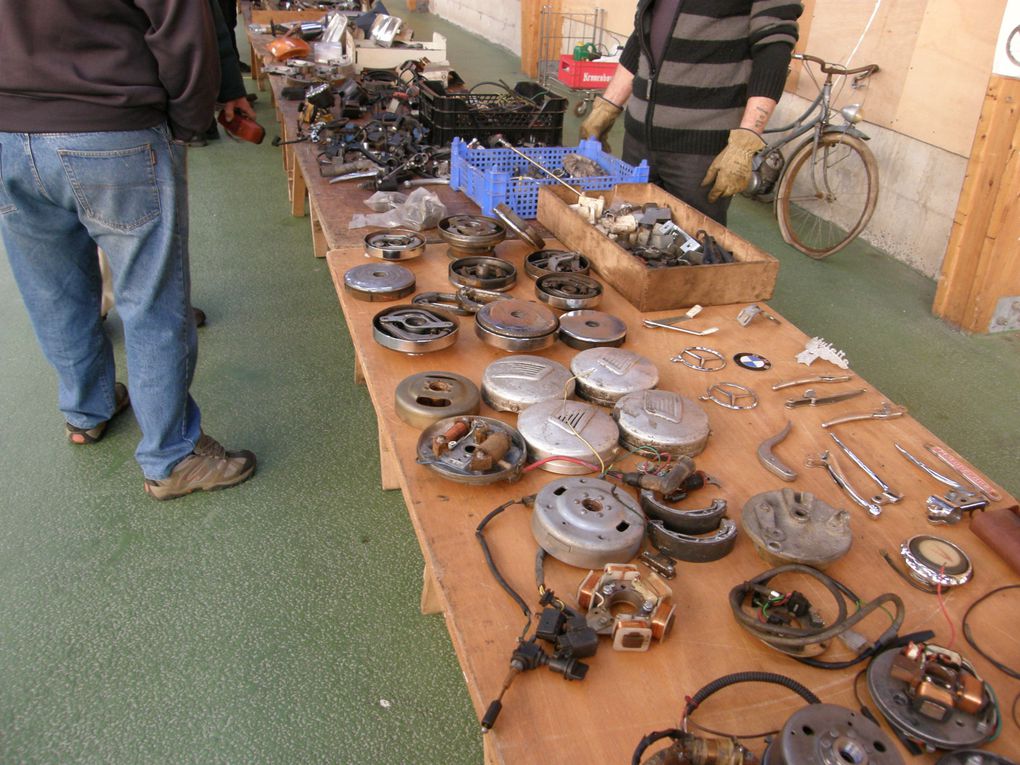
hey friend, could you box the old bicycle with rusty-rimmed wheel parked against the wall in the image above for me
[746,53,878,259]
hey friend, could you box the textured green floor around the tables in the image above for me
[0,5,1020,765]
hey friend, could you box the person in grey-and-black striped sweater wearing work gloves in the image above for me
[580,0,804,225]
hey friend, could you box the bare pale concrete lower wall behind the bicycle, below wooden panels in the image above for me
[772,93,967,278]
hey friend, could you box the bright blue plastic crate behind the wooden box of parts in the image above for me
[450,138,648,219]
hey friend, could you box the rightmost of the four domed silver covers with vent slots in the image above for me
[613,391,711,457]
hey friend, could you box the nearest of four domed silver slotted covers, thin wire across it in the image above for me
[517,399,620,475]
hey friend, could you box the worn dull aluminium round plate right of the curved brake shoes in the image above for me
[741,489,854,568]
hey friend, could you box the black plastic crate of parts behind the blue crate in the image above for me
[419,82,567,146]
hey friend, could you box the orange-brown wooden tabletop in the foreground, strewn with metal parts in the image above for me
[327,236,1020,765]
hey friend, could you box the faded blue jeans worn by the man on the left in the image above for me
[0,125,201,479]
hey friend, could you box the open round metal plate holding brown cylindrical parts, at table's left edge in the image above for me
[418,417,527,486]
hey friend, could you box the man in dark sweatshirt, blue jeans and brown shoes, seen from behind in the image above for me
[0,0,255,500]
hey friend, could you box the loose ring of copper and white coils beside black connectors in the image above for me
[577,563,676,651]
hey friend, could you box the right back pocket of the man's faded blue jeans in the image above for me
[58,144,159,232]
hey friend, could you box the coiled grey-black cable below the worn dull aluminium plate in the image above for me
[729,563,907,669]
